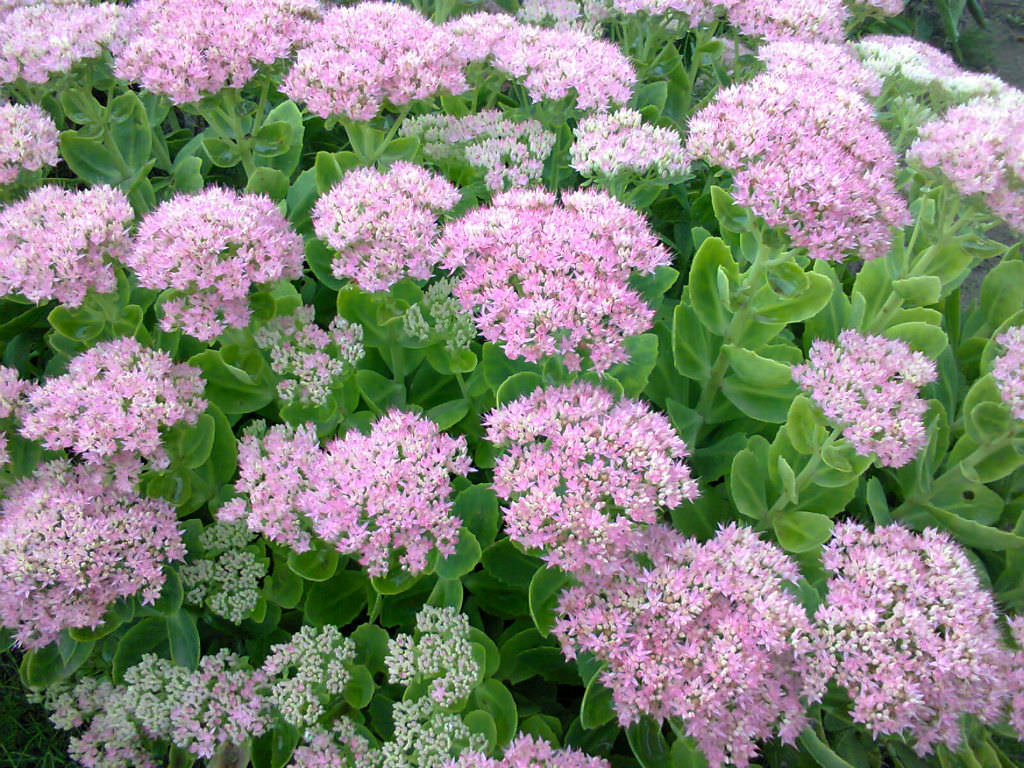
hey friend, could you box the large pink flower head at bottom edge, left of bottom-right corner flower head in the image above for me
[554,523,830,768]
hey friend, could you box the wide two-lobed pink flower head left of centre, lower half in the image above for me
[219,411,470,575]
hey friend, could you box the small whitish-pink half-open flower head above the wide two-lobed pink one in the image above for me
[253,305,364,406]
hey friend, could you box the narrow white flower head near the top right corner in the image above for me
[855,35,1007,101]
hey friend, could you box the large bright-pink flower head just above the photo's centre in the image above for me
[442,189,672,372]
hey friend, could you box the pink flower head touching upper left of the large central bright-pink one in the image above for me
[312,162,460,291]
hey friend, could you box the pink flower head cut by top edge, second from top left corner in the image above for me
[115,0,319,104]
